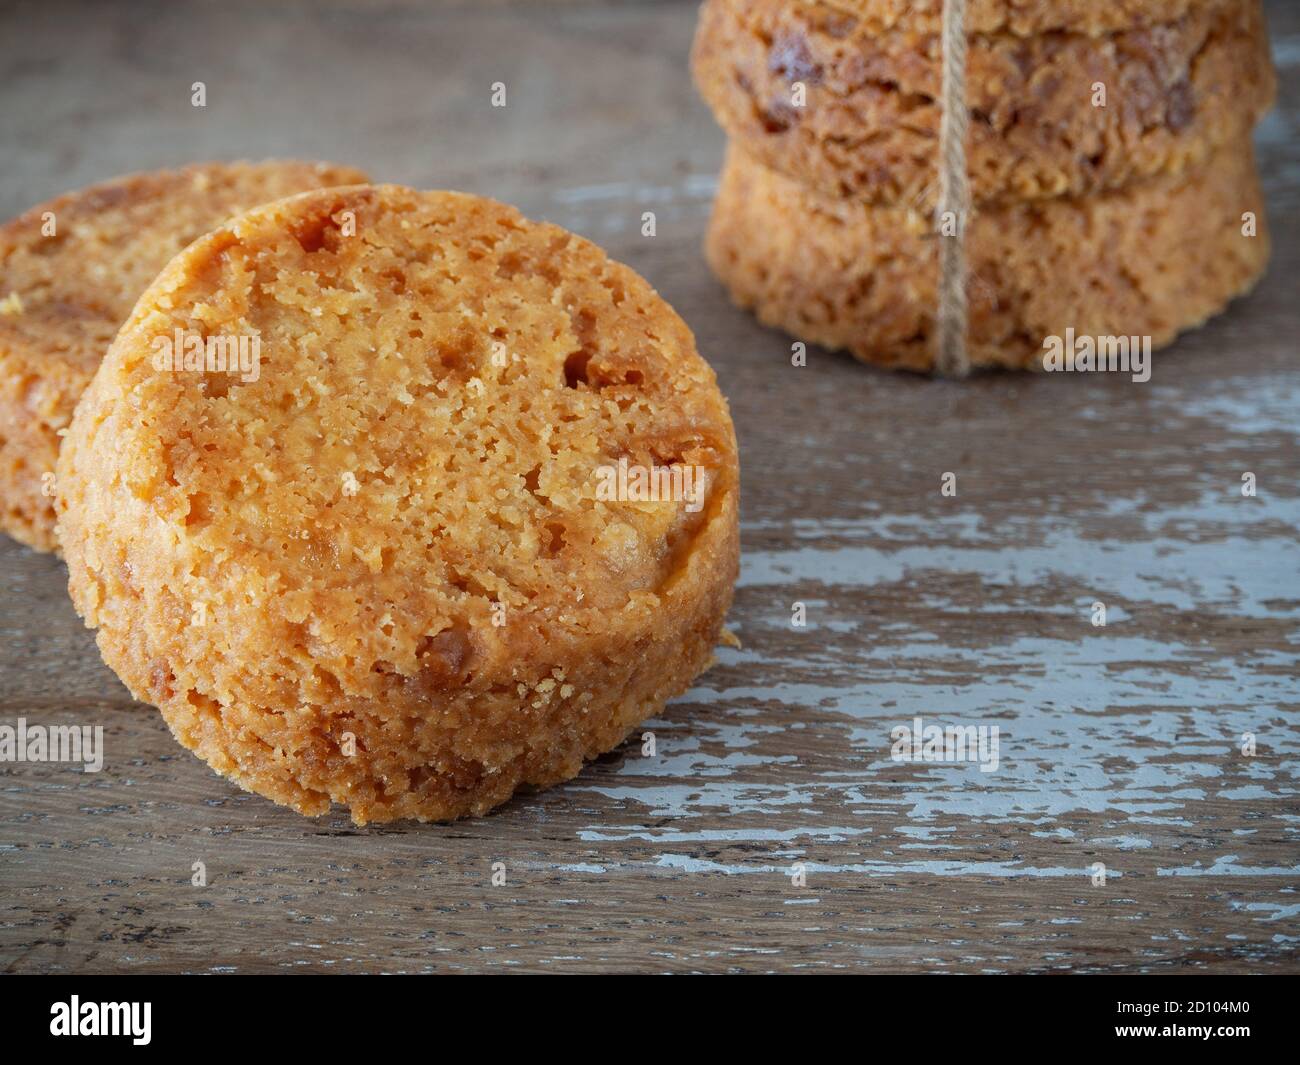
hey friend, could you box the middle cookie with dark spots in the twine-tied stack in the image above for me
[693,0,1275,207]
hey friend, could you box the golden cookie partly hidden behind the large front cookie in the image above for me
[0,161,367,551]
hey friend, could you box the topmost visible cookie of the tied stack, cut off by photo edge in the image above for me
[820,0,1216,36]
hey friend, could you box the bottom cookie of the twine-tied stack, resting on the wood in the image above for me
[706,139,1269,371]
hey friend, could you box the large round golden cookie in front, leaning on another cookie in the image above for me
[59,186,738,824]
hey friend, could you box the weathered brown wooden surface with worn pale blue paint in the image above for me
[0,0,1300,973]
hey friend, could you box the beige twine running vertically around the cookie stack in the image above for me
[935,0,971,377]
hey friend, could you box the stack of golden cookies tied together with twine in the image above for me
[693,0,1274,371]
